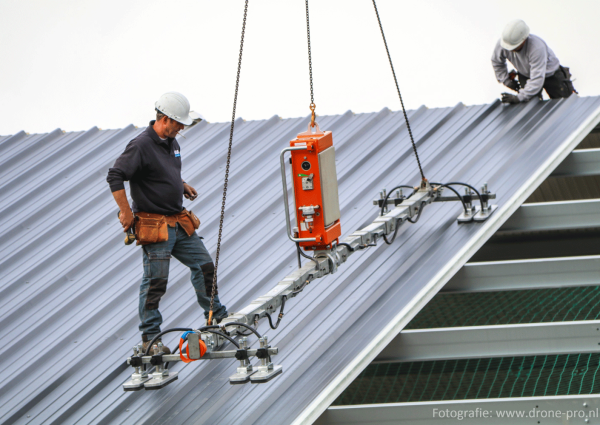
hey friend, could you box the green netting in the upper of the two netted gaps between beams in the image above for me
[405,286,600,329]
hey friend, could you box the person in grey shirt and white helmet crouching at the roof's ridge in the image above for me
[492,19,577,103]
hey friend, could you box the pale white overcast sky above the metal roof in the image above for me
[0,0,600,135]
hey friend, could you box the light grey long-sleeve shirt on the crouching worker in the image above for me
[492,34,560,102]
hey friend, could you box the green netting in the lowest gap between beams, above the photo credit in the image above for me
[333,353,600,405]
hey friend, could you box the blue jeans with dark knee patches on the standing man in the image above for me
[139,224,227,336]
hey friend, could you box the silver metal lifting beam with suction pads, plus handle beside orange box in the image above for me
[123,171,497,391]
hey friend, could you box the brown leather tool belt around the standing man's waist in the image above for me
[135,208,200,245]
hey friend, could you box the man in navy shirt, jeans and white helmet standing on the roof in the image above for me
[106,92,227,352]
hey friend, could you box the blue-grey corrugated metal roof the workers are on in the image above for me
[0,96,600,424]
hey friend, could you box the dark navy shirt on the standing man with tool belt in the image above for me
[106,121,183,215]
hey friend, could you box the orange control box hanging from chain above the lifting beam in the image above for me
[290,127,342,250]
